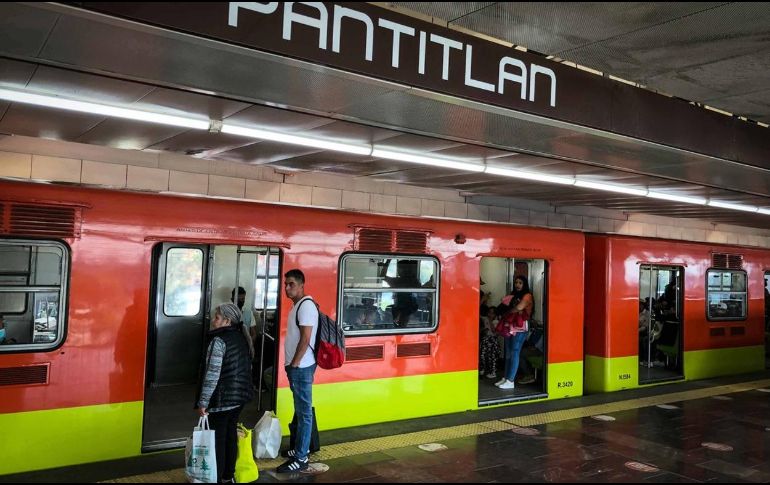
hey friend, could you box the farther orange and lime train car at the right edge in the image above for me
[585,235,770,392]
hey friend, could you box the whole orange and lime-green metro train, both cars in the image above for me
[0,181,770,474]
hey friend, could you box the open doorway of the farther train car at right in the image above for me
[636,265,684,384]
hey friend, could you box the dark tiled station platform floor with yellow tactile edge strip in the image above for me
[0,372,770,483]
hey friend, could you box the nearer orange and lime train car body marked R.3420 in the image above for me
[0,182,584,474]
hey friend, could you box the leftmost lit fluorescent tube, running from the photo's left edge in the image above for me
[0,89,210,130]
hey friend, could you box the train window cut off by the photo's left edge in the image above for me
[0,240,69,352]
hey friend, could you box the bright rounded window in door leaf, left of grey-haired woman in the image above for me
[163,248,203,317]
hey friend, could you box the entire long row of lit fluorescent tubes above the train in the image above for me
[0,88,770,215]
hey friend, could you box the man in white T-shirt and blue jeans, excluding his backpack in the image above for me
[276,269,318,473]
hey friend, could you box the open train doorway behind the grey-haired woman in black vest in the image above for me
[142,243,281,451]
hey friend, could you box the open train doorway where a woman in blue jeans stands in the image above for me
[478,257,548,405]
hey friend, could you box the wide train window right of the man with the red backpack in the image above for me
[337,254,439,335]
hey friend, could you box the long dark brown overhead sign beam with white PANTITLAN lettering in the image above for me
[75,2,770,167]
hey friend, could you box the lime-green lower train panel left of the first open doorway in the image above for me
[0,401,144,475]
